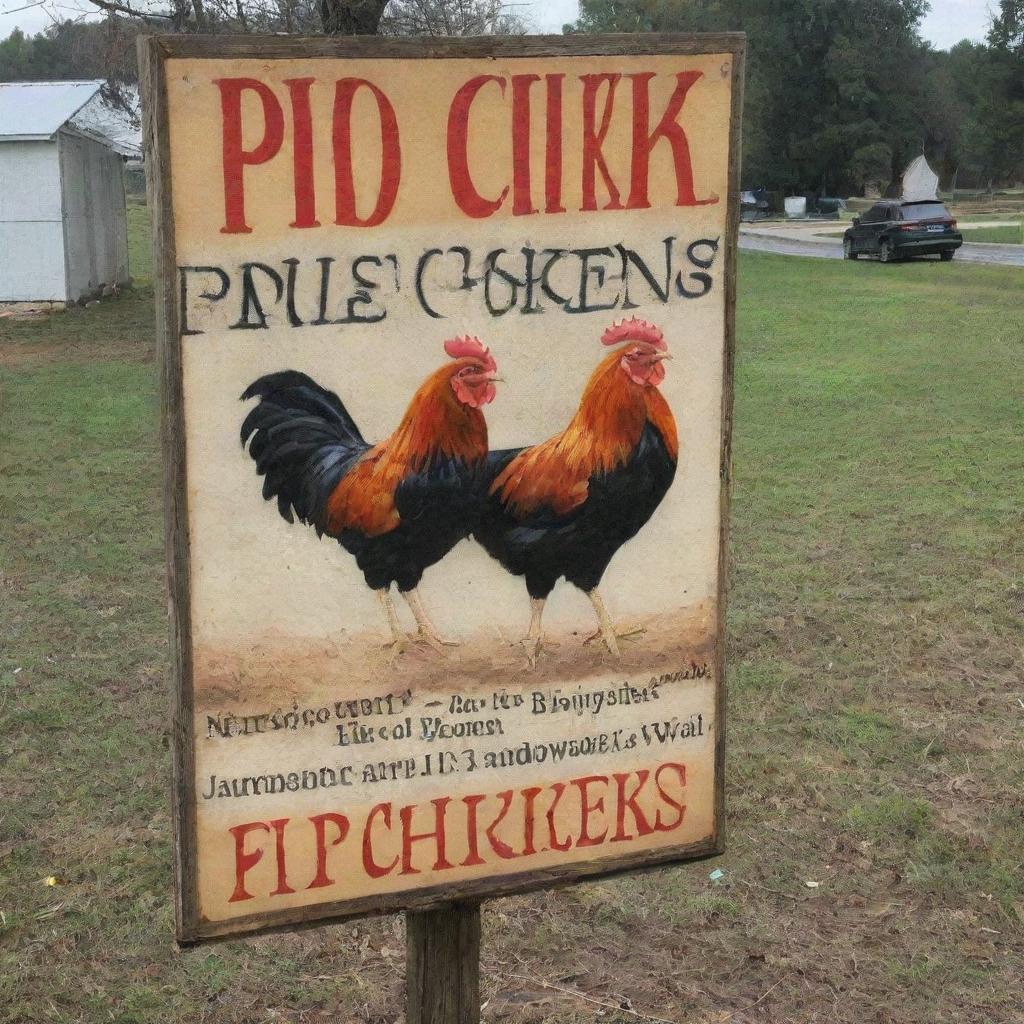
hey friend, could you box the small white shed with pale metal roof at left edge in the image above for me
[0,82,129,302]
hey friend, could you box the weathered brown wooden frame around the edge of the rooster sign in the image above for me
[138,33,745,943]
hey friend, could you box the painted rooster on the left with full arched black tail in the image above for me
[242,337,498,650]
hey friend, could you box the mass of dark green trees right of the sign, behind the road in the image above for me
[574,0,1024,195]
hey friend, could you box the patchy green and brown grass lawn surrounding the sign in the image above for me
[0,208,1024,1024]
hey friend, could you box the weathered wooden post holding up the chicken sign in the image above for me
[406,903,480,1024]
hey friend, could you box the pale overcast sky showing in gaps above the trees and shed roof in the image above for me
[0,0,995,49]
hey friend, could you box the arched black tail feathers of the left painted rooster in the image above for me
[241,370,369,535]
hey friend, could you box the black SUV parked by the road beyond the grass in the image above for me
[843,200,964,263]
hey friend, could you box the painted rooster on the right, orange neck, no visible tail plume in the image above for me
[474,318,679,664]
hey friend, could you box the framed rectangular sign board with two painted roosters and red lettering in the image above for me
[142,35,742,940]
